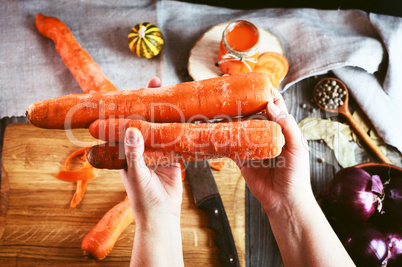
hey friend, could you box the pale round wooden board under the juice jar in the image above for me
[187,23,283,81]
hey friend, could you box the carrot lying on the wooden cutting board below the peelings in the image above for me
[81,197,134,260]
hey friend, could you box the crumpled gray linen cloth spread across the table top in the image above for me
[0,0,402,151]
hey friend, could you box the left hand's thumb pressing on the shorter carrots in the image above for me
[124,127,151,184]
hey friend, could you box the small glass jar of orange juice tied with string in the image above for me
[218,20,260,74]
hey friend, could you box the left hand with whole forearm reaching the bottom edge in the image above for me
[120,77,184,266]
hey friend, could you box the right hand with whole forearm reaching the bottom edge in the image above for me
[241,88,354,267]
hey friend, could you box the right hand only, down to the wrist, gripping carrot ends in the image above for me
[237,90,312,216]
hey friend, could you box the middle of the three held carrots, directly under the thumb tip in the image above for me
[89,119,284,159]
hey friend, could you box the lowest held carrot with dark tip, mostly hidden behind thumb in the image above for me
[87,143,217,170]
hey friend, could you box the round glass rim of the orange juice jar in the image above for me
[222,20,260,57]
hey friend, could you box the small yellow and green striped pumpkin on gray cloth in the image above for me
[128,22,163,58]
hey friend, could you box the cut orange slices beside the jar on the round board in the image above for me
[253,52,289,88]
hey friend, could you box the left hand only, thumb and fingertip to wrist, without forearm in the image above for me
[120,77,183,224]
